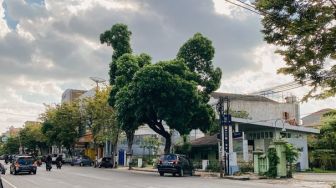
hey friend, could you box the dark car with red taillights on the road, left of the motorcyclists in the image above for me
[10,155,37,175]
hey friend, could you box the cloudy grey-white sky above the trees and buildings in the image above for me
[0,0,336,132]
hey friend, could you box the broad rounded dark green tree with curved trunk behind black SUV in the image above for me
[116,60,215,153]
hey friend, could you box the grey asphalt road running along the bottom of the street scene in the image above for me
[1,165,328,188]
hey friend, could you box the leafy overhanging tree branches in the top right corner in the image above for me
[255,0,336,100]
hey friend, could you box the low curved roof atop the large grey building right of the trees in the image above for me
[211,92,278,103]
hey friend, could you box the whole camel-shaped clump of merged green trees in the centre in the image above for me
[100,24,221,153]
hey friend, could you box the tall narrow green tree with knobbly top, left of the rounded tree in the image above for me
[100,24,151,159]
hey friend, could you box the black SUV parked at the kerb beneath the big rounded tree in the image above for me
[157,154,194,176]
